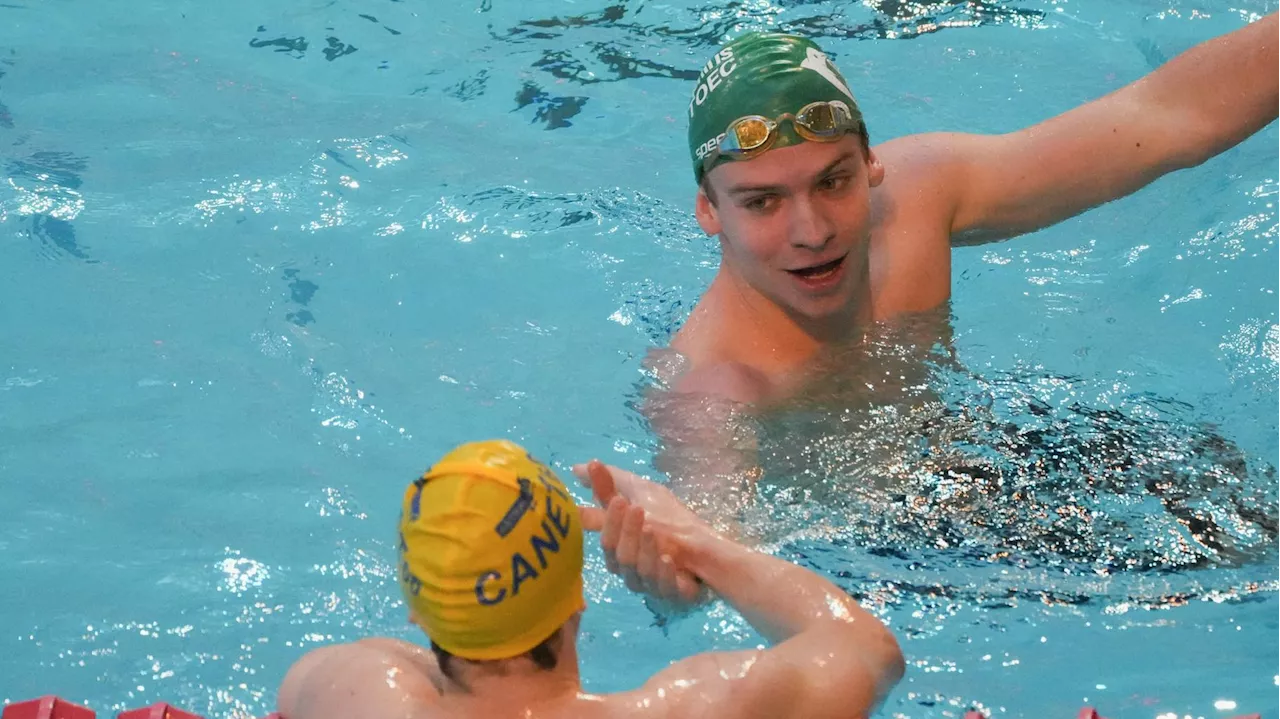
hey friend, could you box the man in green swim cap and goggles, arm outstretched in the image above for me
[671,19,1280,404]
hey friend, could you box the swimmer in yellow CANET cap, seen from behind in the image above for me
[278,441,904,719]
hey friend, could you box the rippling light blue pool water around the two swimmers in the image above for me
[0,0,1280,719]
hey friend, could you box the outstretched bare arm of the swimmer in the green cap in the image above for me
[911,13,1280,244]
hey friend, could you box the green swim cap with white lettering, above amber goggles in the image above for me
[689,32,867,183]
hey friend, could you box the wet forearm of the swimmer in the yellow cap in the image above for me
[685,533,888,644]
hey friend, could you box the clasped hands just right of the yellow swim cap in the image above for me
[573,461,710,610]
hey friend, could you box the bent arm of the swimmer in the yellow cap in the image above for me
[581,460,904,719]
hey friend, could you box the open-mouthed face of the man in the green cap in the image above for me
[696,134,884,319]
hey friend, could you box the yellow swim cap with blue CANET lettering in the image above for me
[399,440,586,659]
